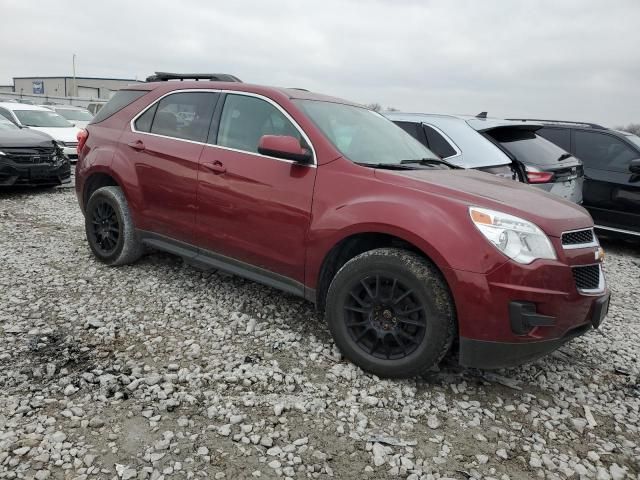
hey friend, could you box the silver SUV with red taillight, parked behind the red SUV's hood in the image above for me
[385,112,584,203]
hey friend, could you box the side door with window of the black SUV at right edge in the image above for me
[573,129,640,232]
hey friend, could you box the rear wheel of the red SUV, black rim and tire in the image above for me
[84,186,142,266]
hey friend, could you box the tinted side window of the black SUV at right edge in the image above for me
[573,130,638,173]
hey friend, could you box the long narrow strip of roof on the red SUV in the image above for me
[127,80,363,107]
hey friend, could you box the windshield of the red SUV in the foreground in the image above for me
[294,100,439,165]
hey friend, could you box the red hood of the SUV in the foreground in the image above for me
[375,169,593,237]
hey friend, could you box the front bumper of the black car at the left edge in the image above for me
[0,159,71,187]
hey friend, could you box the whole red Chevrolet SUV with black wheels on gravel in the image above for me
[76,75,609,377]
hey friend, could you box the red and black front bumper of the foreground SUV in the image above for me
[445,242,609,368]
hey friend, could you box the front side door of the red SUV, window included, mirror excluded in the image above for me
[196,93,316,284]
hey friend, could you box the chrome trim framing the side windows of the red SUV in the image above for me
[129,88,318,168]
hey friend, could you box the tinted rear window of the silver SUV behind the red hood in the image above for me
[487,127,567,166]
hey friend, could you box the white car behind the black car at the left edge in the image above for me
[0,102,80,163]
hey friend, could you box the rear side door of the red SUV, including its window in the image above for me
[120,91,219,243]
